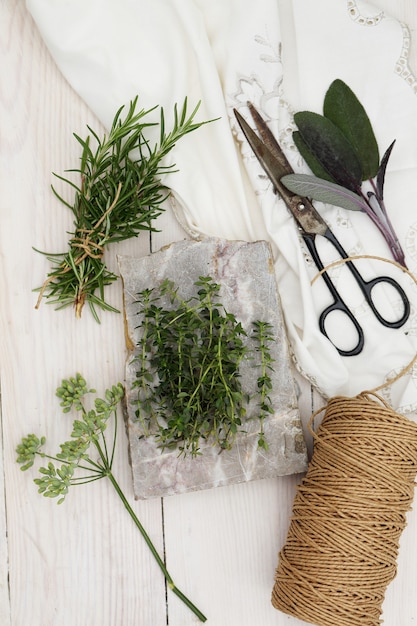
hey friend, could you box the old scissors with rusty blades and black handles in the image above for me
[234,103,410,356]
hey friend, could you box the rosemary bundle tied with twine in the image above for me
[36,97,210,321]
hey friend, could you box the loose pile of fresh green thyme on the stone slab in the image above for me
[133,276,273,456]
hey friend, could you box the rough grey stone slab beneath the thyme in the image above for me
[118,239,307,499]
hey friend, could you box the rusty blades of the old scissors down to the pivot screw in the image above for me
[234,104,328,235]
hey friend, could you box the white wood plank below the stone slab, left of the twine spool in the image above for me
[164,476,299,626]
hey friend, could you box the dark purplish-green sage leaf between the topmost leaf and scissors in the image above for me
[294,111,362,191]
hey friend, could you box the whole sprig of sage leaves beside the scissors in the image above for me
[281,79,406,267]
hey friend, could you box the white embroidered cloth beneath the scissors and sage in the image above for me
[27,0,417,412]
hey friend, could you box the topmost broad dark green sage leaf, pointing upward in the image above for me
[323,79,379,180]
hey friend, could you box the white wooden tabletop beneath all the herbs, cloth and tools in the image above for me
[0,0,417,626]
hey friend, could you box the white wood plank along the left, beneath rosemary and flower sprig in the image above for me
[0,0,166,626]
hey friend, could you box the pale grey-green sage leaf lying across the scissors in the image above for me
[281,174,365,211]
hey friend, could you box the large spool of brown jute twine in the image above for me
[272,257,417,626]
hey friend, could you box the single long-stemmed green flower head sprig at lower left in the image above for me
[16,374,206,622]
